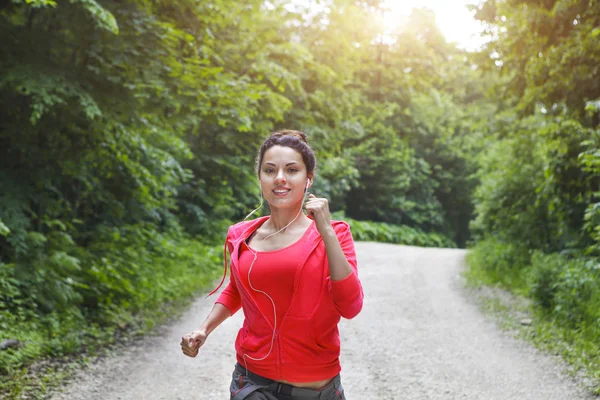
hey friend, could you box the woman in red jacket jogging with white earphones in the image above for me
[181,130,363,400]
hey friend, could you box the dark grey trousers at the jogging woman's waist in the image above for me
[229,363,346,400]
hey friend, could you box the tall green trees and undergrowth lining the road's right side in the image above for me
[469,0,600,390]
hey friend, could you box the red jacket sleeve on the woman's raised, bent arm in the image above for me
[329,222,364,319]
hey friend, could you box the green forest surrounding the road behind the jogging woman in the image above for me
[0,0,600,396]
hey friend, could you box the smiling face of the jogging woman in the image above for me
[259,145,309,208]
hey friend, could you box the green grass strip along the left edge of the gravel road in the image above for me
[0,234,223,400]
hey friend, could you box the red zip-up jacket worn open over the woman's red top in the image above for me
[211,216,364,382]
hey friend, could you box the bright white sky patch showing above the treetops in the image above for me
[385,0,484,50]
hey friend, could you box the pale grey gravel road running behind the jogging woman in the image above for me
[51,242,594,400]
